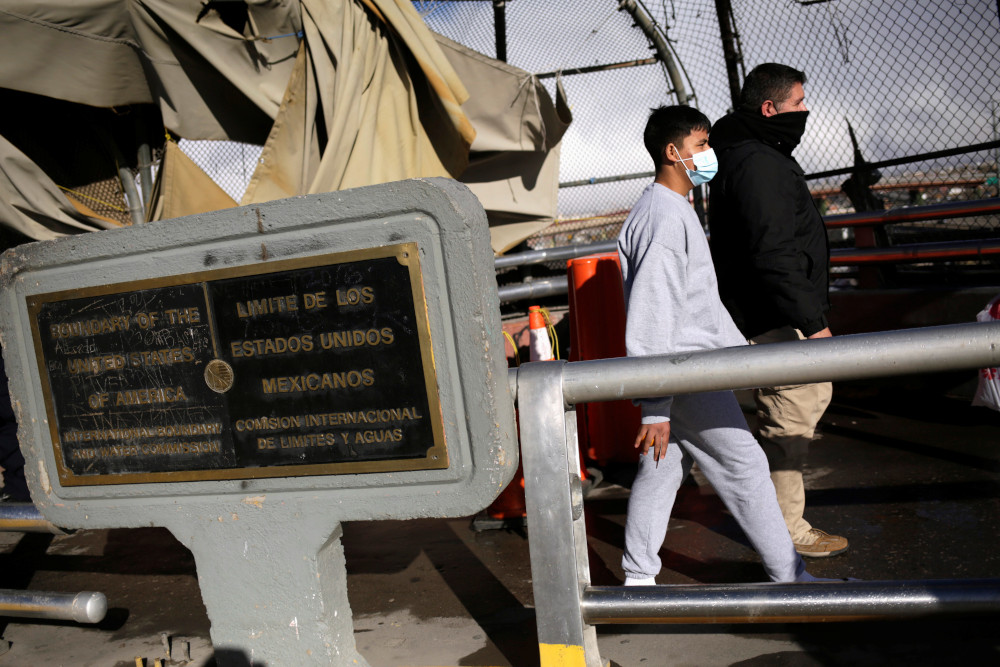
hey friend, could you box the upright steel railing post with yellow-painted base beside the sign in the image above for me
[517,361,601,667]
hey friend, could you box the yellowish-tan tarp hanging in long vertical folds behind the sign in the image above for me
[241,0,475,204]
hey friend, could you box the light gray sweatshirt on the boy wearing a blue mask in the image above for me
[618,183,747,424]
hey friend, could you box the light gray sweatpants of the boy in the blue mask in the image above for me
[622,391,805,582]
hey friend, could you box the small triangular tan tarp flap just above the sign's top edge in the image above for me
[149,141,236,220]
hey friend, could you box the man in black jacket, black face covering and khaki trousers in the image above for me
[709,63,847,557]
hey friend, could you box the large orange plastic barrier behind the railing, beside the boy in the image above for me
[566,253,640,465]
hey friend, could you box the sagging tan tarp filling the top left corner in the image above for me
[0,0,300,141]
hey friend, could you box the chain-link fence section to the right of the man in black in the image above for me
[716,0,1000,258]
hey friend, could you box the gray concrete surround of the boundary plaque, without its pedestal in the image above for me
[0,179,518,528]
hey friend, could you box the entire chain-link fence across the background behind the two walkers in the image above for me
[180,0,1000,264]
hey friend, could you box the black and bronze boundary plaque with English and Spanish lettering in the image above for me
[26,243,448,486]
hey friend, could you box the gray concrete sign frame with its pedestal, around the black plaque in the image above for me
[0,179,518,665]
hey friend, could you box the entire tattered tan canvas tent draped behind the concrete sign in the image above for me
[0,0,570,251]
